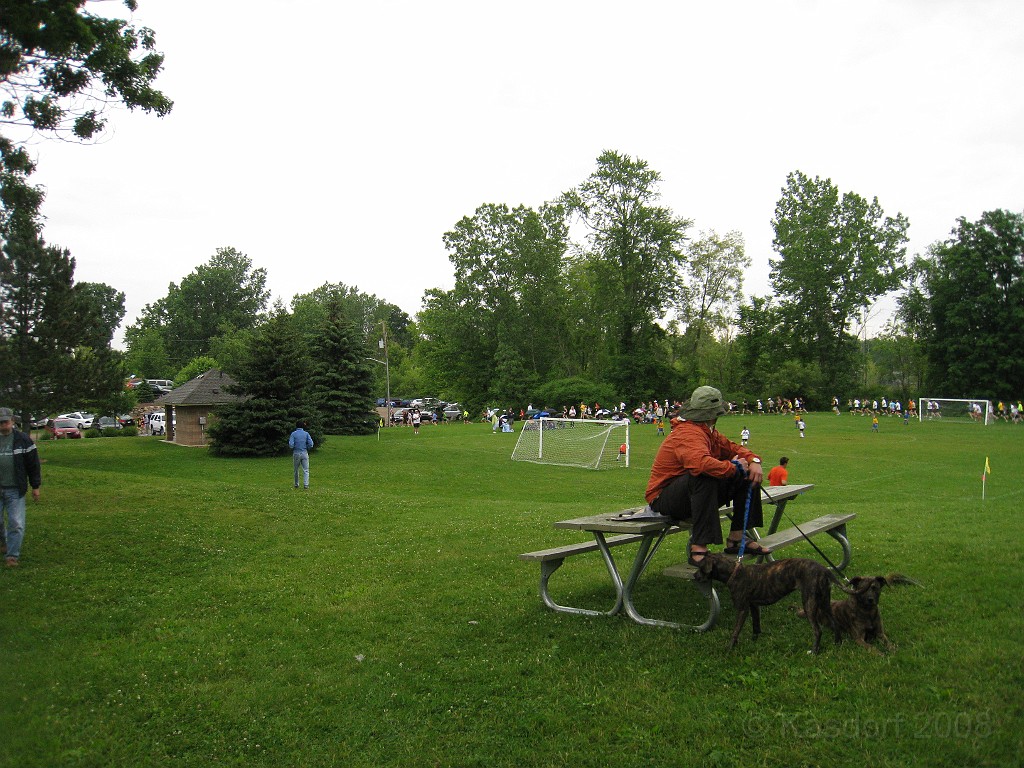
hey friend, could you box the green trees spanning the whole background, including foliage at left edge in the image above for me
[0,0,1024,430]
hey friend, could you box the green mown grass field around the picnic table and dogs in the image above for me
[0,414,1024,767]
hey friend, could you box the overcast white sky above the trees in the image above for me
[22,0,1024,348]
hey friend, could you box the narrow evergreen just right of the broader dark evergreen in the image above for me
[309,299,378,434]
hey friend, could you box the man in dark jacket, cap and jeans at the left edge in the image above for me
[0,408,42,568]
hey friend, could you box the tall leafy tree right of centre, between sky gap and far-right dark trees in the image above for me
[769,171,909,400]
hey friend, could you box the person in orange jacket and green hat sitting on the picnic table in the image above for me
[644,387,764,565]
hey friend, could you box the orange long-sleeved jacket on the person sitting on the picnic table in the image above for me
[644,419,759,504]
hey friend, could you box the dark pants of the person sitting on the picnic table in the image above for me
[650,475,764,547]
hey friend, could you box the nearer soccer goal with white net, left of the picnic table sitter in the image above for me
[512,417,630,469]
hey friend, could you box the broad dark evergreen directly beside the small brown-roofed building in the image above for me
[209,307,324,456]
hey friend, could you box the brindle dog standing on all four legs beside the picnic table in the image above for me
[693,553,835,653]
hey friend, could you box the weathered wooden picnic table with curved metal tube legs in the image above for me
[519,483,856,632]
